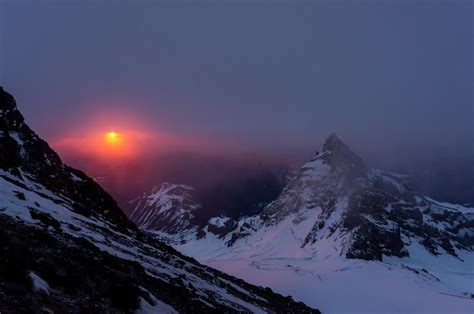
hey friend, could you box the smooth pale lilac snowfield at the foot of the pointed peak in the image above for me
[175,219,474,313]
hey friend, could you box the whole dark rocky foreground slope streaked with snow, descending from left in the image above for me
[0,88,317,313]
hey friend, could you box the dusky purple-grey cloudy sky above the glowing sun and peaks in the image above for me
[0,0,474,166]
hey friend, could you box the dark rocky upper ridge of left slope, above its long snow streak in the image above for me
[0,88,130,223]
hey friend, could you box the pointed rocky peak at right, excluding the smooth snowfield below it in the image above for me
[261,134,474,260]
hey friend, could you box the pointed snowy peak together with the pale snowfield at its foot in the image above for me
[141,134,474,313]
